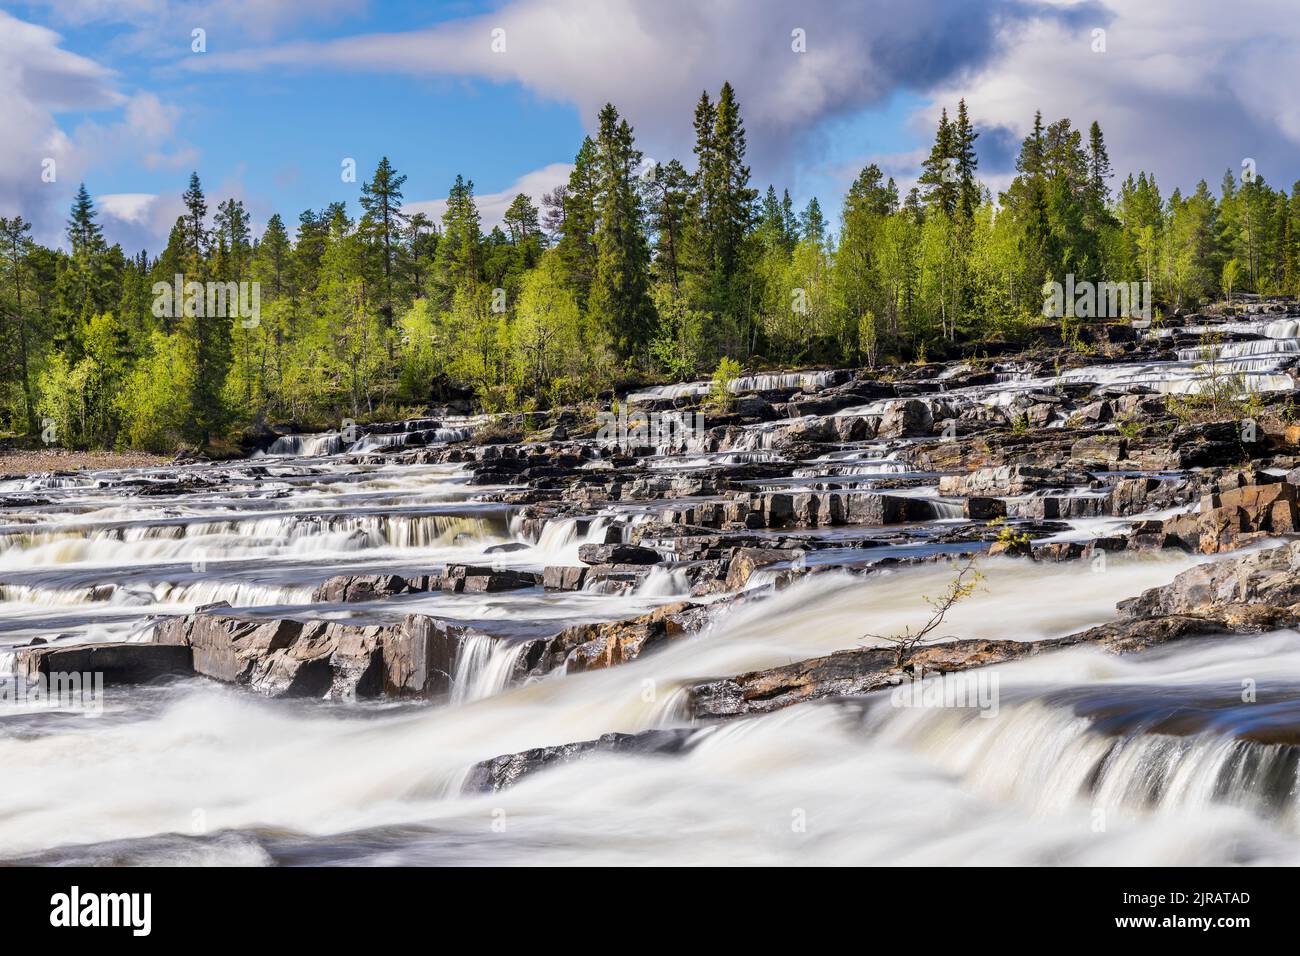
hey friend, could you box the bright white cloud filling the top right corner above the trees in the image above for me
[923,0,1300,195]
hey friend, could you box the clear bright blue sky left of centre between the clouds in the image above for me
[40,3,584,219]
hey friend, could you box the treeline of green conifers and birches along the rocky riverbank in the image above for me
[0,85,1300,451]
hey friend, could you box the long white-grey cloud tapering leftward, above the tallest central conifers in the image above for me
[177,0,1095,181]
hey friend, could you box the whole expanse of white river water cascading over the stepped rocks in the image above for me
[0,308,1300,865]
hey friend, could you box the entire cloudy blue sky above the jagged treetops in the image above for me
[0,0,1300,255]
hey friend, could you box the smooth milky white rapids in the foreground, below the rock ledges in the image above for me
[0,559,1300,864]
